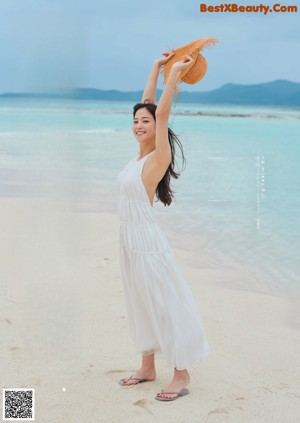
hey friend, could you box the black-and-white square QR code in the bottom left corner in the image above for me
[3,389,34,420]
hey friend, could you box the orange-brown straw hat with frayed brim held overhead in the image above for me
[163,38,218,93]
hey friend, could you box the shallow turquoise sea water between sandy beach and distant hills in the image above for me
[0,99,300,294]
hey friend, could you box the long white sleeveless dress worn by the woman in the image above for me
[118,150,210,370]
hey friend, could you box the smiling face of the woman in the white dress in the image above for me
[132,107,156,143]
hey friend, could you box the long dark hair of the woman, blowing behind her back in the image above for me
[133,100,186,206]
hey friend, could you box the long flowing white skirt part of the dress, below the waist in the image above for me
[119,242,210,370]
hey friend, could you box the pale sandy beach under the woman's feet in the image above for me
[0,198,300,423]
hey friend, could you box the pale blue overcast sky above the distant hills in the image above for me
[0,0,300,93]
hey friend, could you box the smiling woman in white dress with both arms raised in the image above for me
[118,52,209,401]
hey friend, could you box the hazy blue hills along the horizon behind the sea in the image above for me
[0,80,300,107]
